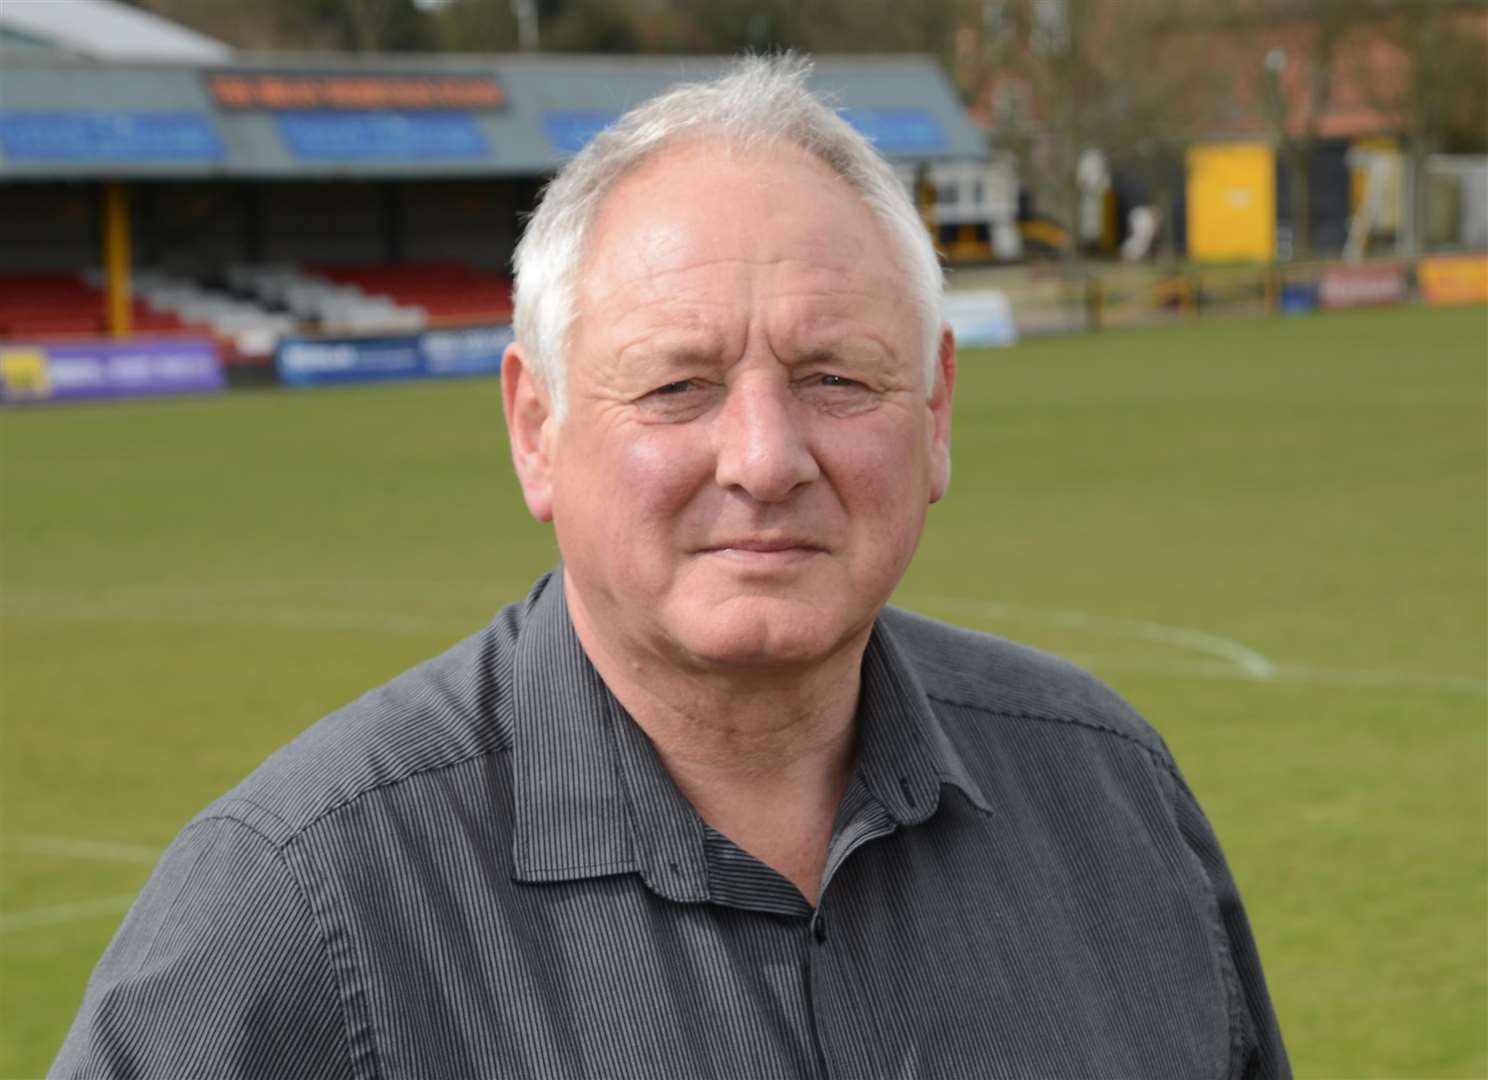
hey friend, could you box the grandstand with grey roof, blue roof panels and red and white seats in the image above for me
[0,43,1015,367]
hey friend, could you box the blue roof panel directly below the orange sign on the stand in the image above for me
[274,110,491,161]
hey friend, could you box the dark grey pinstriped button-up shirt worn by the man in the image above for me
[54,576,1290,1080]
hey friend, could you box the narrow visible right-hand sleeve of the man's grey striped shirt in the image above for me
[1170,771,1292,1080]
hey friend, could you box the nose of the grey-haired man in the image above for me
[714,378,821,503]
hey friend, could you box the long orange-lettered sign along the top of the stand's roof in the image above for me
[207,71,506,112]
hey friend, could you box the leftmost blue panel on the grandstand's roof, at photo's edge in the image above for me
[0,112,223,162]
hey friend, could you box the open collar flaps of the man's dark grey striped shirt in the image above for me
[512,568,987,901]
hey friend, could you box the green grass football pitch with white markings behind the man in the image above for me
[0,301,1488,1077]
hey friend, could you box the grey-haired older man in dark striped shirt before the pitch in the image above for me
[55,60,1287,1080]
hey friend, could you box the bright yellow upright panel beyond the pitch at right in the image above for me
[1187,143,1277,262]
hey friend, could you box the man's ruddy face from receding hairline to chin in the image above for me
[509,143,954,671]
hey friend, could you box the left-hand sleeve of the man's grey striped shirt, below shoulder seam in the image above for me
[49,817,351,1080]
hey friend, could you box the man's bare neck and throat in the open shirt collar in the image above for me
[567,589,868,904]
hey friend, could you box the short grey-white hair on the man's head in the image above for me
[512,54,943,417]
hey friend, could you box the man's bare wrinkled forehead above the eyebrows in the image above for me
[570,141,918,389]
